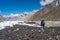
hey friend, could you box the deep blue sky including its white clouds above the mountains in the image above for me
[0,0,53,15]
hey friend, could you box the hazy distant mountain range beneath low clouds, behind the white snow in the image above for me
[0,13,33,22]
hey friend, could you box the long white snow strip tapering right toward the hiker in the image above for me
[0,21,41,30]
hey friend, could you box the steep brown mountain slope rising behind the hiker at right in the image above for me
[29,0,60,21]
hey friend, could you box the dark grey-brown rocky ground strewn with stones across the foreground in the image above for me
[0,25,60,40]
